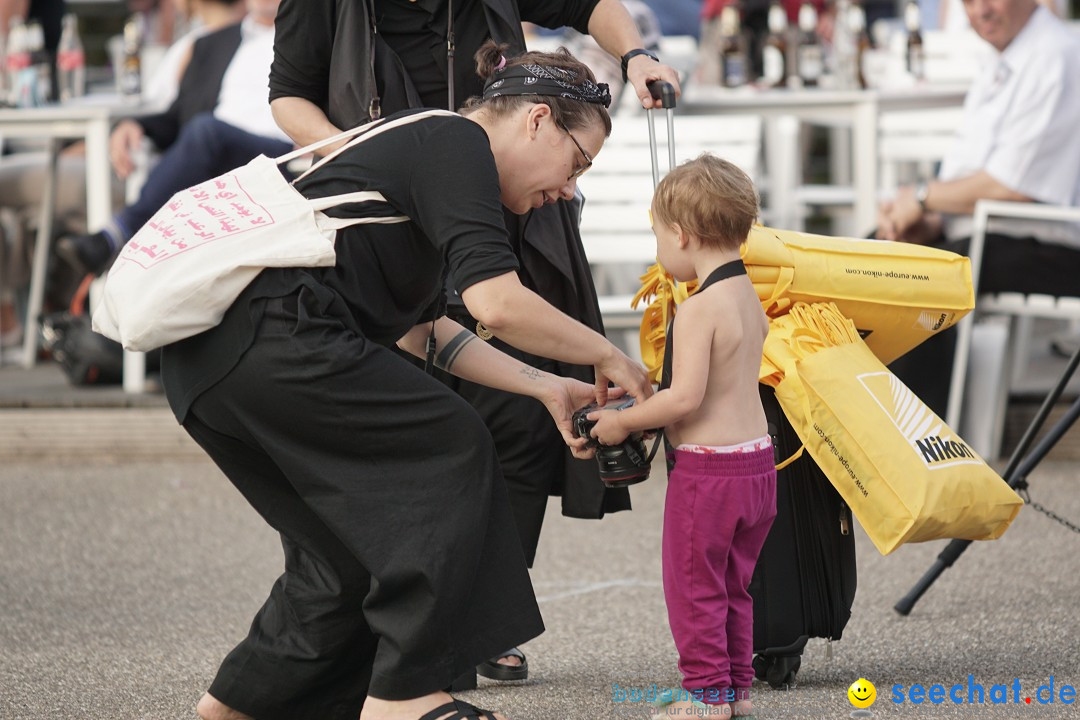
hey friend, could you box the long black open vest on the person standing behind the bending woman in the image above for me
[270,0,630,518]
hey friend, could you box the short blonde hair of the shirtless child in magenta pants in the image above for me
[652,152,758,249]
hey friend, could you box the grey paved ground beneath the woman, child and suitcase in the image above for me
[0,451,1080,720]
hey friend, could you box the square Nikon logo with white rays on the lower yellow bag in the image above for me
[859,371,983,470]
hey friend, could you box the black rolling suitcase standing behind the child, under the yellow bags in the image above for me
[750,385,855,688]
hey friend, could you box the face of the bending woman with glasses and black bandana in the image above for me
[499,105,605,215]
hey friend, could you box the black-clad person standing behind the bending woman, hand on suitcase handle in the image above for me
[270,0,678,687]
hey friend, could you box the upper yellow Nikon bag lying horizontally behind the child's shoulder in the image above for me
[742,226,975,364]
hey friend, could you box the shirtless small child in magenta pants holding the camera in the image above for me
[589,154,777,718]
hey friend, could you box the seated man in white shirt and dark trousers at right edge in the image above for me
[877,0,1080,417]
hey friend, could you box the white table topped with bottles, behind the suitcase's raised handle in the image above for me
[676,85,967,232]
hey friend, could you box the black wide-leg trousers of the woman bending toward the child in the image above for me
[185,288,543,720]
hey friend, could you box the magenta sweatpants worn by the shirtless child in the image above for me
[663,447,777,705]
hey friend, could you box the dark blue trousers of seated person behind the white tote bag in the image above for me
[113,112,293,243]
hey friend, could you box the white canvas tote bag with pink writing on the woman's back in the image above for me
[93,110,455,351]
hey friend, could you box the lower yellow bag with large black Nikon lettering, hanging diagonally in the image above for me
[760,303,1023,555]
